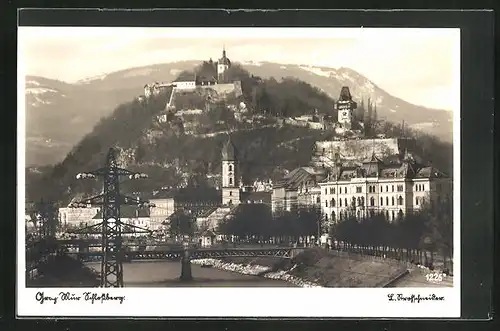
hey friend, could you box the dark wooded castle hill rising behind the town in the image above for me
[26,63,452,204]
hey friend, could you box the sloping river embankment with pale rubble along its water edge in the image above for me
[193,249,408,287]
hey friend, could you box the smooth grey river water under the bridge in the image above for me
[86,260,295,287]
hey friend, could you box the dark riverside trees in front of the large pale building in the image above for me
[167,199,453,270]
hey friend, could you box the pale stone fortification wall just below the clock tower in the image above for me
[314,138,417,160]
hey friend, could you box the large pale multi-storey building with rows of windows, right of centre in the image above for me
[319,152,452,222]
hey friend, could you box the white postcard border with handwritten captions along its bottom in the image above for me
[16,27,461,317]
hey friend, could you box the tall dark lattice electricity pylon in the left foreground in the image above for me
[70,148,153,287]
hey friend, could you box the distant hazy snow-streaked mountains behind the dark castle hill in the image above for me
[25,61,452,166]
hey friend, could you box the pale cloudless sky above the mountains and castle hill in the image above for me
[18,27,460,110]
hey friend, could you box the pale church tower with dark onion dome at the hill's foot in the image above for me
[222,137,240,205]
